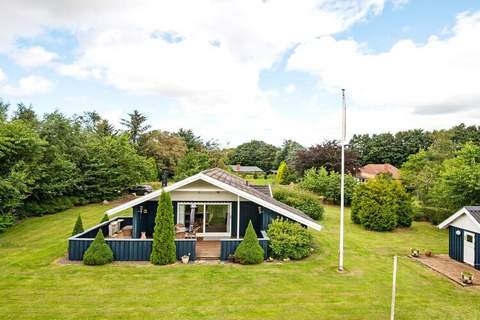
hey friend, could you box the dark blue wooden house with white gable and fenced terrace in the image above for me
[69,168,322,260]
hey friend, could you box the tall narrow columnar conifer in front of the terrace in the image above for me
[150,192,176,265]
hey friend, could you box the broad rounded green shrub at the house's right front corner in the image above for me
[267,219,313,260]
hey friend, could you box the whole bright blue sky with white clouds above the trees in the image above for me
[0,0,480,145]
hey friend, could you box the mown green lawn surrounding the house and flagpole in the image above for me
[0,205,480,319]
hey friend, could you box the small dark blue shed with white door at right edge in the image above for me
[438,206,480,270]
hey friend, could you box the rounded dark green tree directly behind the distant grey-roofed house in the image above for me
[229,140,278,171]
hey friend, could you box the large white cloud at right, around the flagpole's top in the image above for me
[288,12,480,114]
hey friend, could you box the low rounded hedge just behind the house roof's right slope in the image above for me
[273,187,325,220]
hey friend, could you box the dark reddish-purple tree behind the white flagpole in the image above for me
[295,140,358,175]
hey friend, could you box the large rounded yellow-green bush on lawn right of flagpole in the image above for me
[351,175,413,231]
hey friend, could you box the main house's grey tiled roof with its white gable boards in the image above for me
[106,168,322,230]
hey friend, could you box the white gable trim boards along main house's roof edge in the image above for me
[106,172,322,231]
